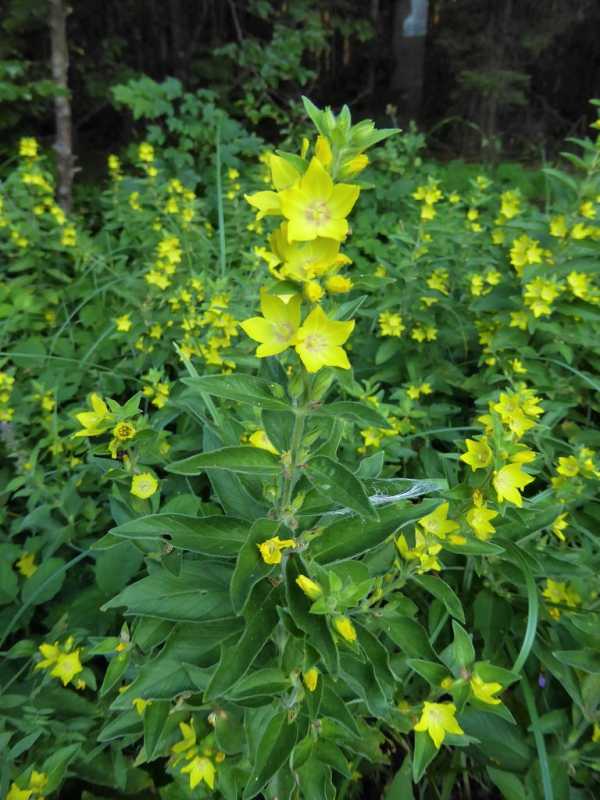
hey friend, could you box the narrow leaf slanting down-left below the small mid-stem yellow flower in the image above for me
[206,585,277,700]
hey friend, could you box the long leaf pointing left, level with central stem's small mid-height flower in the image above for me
[110,514,248,556]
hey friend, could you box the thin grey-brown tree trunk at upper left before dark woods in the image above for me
[50,0,74,211]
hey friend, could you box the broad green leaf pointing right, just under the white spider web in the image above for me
[310,499,439,564]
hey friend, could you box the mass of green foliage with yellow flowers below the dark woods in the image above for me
[0,94,600,800]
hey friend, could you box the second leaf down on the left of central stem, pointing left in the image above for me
[165,445,281,478]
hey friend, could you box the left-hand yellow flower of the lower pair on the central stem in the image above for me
[241,291,301,358]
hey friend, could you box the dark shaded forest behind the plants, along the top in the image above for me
[0,0,600,166]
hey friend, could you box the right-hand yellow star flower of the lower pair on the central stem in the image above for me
[295,306,354,372]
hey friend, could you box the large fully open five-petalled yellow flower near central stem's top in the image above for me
[280,158,360,242]
